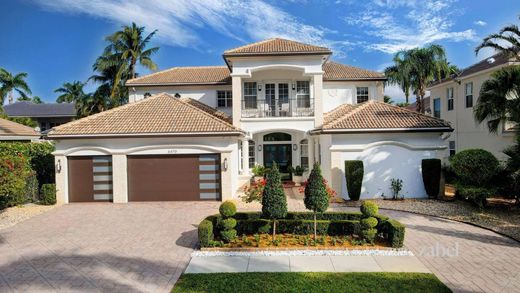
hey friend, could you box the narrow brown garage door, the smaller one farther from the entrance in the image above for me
[67,156,112,202]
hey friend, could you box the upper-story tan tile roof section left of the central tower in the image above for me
[126,66,231,86]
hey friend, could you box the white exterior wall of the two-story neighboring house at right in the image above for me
[430,66,514,160]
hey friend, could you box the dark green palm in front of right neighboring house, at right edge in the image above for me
[473,66,520,133]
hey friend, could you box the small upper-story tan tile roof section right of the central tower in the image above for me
[323,61,386,81]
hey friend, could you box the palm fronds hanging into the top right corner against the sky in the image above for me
[475,16,520,61]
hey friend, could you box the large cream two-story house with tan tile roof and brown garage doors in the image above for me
[48,39,451,203]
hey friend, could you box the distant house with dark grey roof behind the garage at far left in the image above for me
[4,101,76,132]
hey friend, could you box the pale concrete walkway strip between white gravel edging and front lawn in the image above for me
[185,256,431,274]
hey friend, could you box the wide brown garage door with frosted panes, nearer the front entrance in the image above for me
[127,154,220,201]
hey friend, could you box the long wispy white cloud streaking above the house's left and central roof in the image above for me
[33,0,350,55]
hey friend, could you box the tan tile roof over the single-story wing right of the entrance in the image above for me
[318,101,451,132]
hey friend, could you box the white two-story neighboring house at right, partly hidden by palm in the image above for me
[428,54,518,159]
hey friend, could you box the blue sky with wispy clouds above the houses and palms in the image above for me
[0,0,520,102]
